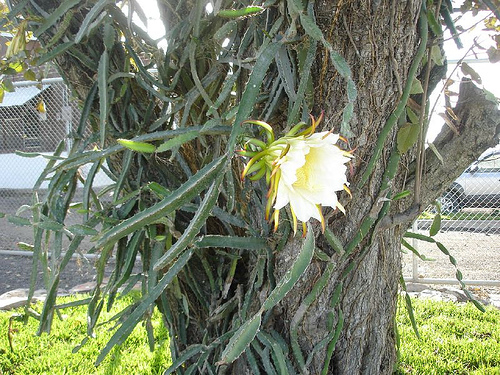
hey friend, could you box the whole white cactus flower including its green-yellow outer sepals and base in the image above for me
[239,116,352,232]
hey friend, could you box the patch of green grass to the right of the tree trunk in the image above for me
[397,299,500,375]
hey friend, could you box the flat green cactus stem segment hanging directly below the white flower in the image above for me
[261,228,315,311]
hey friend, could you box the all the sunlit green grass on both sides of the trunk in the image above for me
[0,296,500,375]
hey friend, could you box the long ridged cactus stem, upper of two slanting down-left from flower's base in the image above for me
[96,155,227,248]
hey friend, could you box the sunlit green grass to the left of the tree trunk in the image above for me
[0,295,171,375]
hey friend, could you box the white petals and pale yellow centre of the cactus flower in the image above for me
[274,132,350,232]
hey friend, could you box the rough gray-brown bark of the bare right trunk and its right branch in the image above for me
[268,1,500,374]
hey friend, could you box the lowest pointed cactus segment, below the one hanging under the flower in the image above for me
[216,312,262,365]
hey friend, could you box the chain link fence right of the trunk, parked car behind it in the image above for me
[403,147,500,287]
